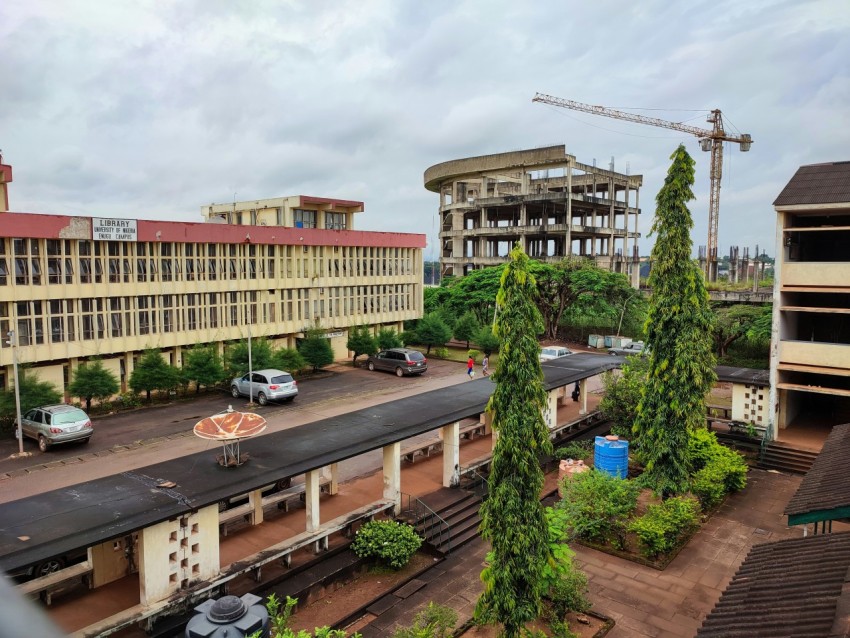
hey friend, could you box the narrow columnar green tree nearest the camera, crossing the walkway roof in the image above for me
[475,246,552,637]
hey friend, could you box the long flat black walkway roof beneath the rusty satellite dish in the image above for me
[0,353,622,571]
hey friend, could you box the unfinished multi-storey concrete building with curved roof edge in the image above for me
[425,145,643,286]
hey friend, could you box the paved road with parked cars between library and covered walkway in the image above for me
[0,359,466,502]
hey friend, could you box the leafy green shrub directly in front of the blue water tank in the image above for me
[556,470,640,547]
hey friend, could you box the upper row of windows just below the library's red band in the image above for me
[0,239,414,286]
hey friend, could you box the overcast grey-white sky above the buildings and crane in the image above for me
[0,0,850,259]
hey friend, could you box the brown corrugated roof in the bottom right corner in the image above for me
[697,532,850,638]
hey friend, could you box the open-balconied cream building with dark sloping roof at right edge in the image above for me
[770,162,850,439]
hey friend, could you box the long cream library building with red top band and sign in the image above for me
[0,166,425,391]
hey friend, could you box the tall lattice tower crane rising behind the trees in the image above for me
[532,93,753,281]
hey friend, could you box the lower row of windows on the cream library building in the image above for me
[0,284,415,347]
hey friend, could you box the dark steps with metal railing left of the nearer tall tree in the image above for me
[401,488,482,554]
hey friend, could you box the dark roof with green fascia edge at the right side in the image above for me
[785,423,850,525]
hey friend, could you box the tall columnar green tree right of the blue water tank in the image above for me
[633,145,717,498]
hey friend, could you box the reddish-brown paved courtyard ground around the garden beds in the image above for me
[359,470,802,638]
